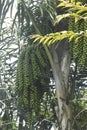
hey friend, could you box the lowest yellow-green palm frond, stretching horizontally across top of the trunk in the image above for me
[30,31,87,45]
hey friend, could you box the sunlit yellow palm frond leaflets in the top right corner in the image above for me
[55,0,87,24]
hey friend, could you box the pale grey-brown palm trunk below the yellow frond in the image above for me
[51,41,72,130]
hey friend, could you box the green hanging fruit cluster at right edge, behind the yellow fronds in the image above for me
[69,0,87,67]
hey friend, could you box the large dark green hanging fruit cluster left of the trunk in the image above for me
[16,45,50,124]
